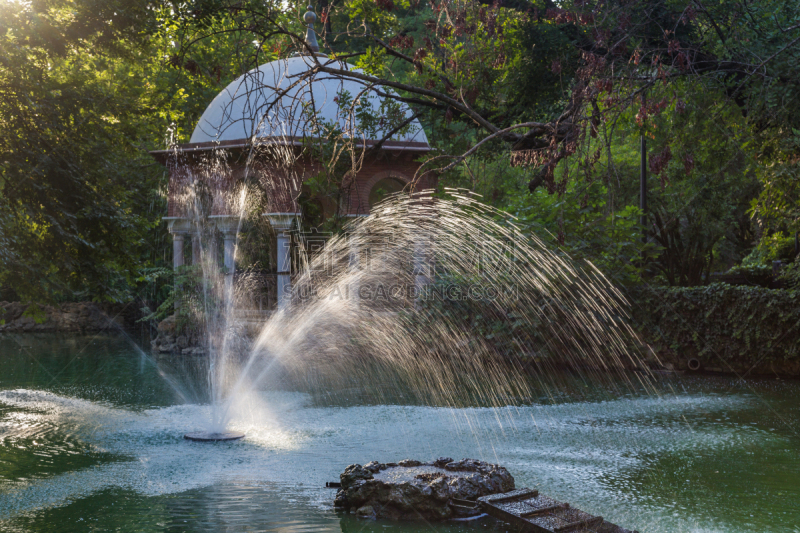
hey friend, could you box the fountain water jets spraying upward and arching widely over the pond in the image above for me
[166,166,647,442]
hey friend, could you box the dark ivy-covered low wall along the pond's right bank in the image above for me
[628,283,800,375]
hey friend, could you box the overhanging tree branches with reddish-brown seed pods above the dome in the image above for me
[164,0,800,170]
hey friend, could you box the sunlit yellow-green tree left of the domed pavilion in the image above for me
[0,0,169,300]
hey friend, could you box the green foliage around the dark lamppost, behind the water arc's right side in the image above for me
[443,77,759,286]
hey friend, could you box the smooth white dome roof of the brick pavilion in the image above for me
[190,56,428,149]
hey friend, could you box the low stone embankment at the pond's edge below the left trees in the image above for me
[0,302,141,333]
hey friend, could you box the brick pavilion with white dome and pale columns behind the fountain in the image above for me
[151,8,436,306]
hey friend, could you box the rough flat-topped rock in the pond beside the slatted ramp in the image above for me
[334,457,514,520]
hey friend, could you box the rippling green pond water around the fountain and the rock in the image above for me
[0,335,800,533]
